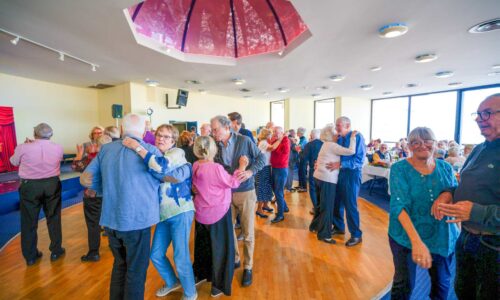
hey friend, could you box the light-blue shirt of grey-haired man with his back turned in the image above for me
[85,138,162,231]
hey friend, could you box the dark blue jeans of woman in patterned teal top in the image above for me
[389,237,455,300]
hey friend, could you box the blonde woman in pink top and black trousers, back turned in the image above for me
[193,136,248,297]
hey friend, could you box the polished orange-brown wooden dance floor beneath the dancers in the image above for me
[0,193,394,300]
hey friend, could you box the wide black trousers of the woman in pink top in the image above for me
[193,209,235,296]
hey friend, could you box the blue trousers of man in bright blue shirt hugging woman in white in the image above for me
[333,168,363,238]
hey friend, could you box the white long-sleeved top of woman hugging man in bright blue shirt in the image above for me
[313,135,356,184]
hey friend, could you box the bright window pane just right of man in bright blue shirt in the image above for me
[371,97,408,142]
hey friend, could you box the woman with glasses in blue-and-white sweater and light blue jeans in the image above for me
[123,124,198,299]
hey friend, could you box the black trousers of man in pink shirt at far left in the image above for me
[19,176,62,260]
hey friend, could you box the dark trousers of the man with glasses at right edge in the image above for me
[455,229,500,299]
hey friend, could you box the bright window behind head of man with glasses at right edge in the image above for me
[460,87,500,144]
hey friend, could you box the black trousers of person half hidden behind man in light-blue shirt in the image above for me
[83,197,102,255]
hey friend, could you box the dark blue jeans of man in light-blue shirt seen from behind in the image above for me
[105,227,151,300]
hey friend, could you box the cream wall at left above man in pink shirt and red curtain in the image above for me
[0,73,99,153]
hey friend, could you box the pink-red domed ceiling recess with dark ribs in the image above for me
[125,0,311,64]
